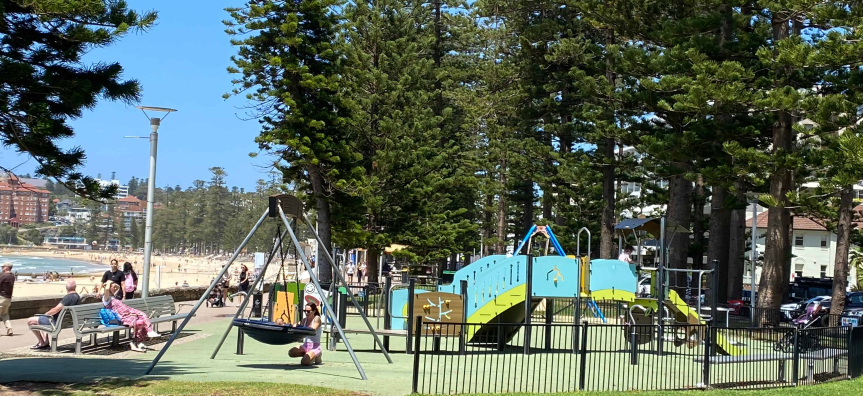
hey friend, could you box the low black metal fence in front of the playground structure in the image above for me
[413,320,863,394]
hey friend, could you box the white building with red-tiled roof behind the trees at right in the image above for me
[744,206,863,286]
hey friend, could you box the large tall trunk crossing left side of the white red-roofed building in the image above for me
[756,12,794,316]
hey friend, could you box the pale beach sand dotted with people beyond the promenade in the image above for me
[2,248,260,297]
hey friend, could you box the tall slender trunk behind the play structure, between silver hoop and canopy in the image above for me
[599,29,615,259]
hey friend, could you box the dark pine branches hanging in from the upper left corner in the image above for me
[0,0,156,199]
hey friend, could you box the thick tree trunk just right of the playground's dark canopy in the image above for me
[667,175,692,295]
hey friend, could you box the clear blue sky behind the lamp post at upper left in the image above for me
[0,0,276,190]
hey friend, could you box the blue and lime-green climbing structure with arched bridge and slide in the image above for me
[385,219,746,355]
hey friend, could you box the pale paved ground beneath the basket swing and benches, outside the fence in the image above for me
[0,300,412,396]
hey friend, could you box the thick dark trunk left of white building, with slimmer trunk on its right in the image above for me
[707,186,731,298]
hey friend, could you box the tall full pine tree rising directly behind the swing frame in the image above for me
[226,0,361,283]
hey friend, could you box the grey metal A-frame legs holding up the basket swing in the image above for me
[144,194,393,380]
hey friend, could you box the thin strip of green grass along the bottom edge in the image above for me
[0,379,852,396]
